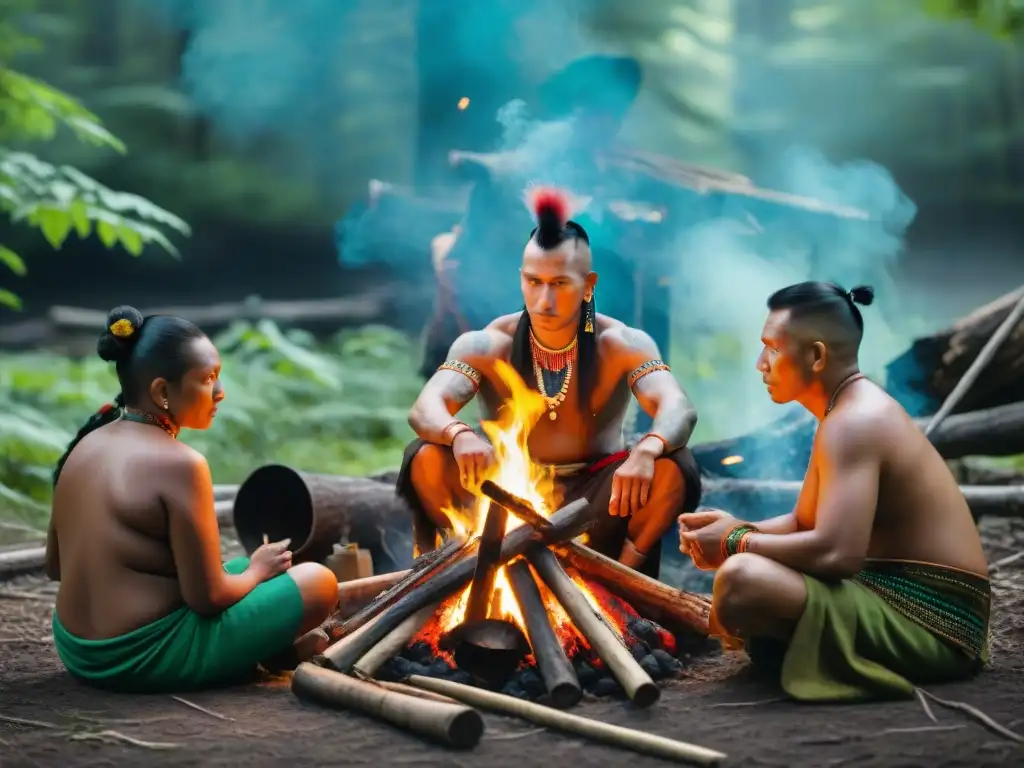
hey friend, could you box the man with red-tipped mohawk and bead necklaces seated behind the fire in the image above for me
[397,187,700,578]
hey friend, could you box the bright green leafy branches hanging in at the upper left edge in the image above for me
[0,6,189,309]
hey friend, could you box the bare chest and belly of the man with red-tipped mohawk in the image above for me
[478,312,632,464]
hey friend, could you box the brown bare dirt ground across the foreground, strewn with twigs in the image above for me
[0,520,1024,768]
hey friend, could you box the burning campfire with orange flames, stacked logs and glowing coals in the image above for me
[316,364,708,709]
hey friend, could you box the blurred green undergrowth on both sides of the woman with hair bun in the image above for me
[0,322,421,544]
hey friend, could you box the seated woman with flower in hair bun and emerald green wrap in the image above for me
[46,306,338,692]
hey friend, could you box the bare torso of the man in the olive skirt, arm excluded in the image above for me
[796,380,988,574]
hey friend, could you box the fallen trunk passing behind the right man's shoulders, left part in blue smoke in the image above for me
[692,401,1024,480]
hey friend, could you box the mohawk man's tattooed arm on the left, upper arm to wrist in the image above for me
[409,331,494,445]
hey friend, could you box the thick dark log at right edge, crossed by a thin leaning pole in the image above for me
[886,288,1024,416]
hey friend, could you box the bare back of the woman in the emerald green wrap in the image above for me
[52,422,189,640]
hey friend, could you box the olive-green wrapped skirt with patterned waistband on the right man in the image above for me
[746,560,991,701]
